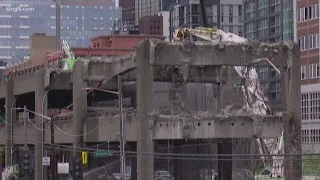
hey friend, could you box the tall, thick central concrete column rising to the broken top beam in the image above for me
[136,40,154,180]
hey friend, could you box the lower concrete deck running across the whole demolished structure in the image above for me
[0,110,282,145]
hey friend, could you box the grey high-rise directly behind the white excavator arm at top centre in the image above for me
[170,0,243,35]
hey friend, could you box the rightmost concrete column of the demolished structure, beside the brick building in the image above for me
[282,44,302,180]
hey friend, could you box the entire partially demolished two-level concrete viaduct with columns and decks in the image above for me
[0,40,302,180]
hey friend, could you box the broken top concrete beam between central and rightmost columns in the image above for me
[150,40,293,67]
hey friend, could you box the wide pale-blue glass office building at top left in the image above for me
[0,0,121,62]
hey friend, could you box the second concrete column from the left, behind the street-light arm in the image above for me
[34,70,48,180]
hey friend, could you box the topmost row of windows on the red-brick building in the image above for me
[297,4,319,22]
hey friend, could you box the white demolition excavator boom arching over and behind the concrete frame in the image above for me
[173,27,284,178]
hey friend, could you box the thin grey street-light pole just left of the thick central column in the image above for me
[118,76,126,180]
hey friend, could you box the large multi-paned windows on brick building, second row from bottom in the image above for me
[301,92,320,120]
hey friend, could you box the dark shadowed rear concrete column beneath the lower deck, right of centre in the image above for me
[218,139,232,180]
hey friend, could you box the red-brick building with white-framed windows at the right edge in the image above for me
[296,0,320,152]
